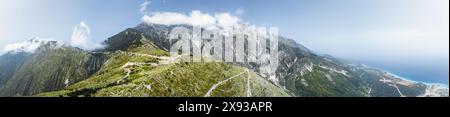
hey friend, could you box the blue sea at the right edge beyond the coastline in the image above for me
[364,58,449,86]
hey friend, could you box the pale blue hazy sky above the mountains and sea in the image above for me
[0,0,449,83]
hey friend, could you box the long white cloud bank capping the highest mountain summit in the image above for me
[142,10,241,27]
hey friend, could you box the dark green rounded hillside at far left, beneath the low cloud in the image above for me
[0,47,106,96]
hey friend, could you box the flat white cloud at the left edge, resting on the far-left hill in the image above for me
[0,37,60,55]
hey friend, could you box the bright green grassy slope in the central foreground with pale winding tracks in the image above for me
[36,42,291,97]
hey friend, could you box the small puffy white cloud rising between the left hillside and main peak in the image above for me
[70,21,102,50]
